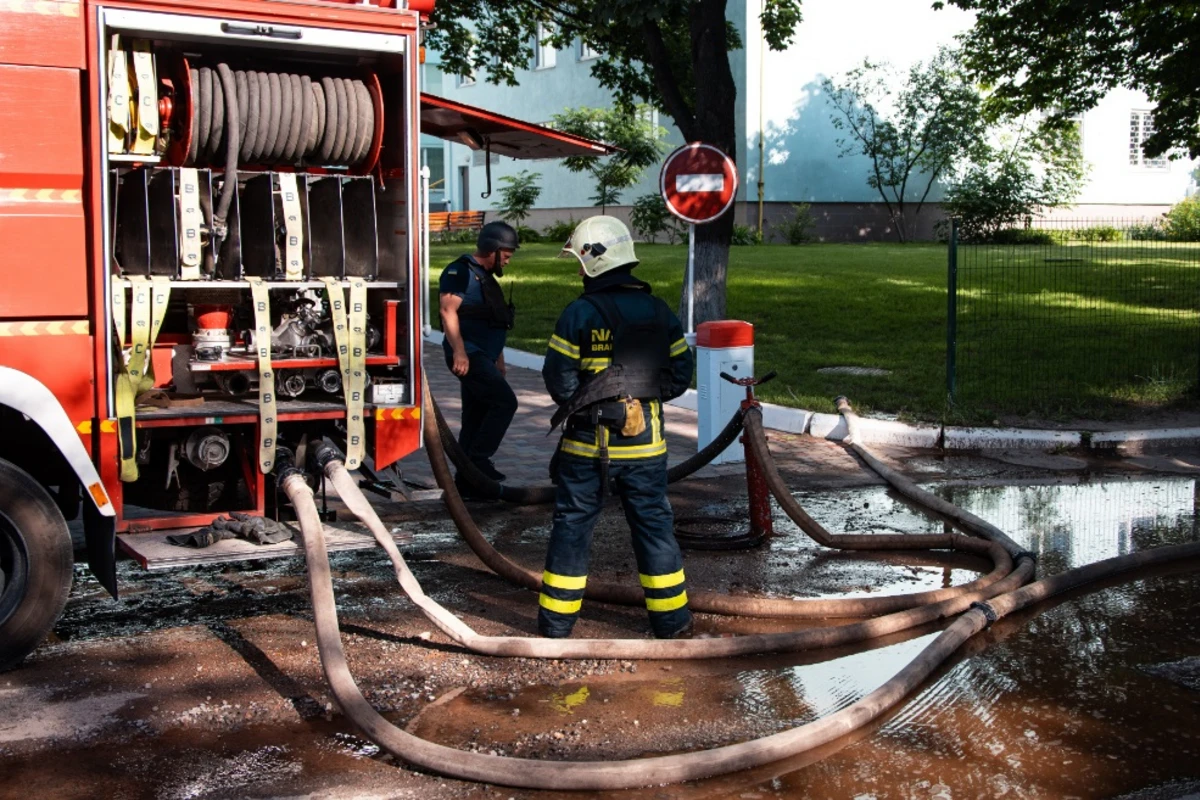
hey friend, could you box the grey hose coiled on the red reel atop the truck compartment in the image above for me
[184,64,376,237]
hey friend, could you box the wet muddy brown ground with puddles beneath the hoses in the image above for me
[0,441,1200,800]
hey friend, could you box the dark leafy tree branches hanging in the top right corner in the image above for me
[934,0,1200,158]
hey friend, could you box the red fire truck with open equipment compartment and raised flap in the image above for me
[0,0,604,668]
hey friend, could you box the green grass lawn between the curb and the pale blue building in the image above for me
[431,243,1200,421]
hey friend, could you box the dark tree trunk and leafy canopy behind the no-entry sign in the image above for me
[426,0,800,321]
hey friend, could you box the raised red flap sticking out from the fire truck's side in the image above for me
[421,94,617,158]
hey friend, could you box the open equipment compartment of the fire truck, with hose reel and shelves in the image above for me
[100,10,416,525]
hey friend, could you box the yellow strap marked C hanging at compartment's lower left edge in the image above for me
[114,275,170,481]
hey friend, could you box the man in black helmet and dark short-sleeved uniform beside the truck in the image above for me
[438,222,521,494]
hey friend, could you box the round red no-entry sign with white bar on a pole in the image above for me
[659,142,738,225]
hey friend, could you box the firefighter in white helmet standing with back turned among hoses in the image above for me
[538,216,695,638]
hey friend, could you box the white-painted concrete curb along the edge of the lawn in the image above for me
[425,331,1200,456]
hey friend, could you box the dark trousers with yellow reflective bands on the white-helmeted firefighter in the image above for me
[538,456,691,638]
